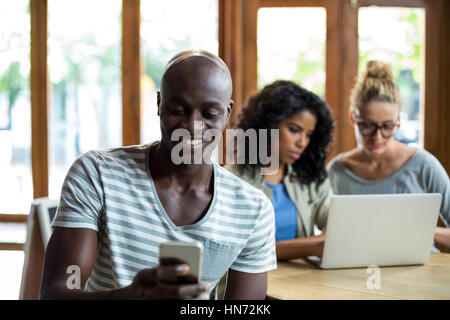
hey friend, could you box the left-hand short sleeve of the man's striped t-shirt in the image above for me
[52,152,104,231]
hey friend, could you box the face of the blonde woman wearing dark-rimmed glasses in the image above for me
[352,101,399,154]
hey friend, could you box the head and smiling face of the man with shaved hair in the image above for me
[158,52,233,168]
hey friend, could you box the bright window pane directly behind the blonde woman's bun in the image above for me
[358,7,425,146]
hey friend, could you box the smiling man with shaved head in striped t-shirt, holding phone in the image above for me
[41,51,276,299]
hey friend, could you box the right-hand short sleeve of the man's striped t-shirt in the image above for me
[230,197,277,273]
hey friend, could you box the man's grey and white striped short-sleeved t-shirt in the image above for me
[52,145,276,291]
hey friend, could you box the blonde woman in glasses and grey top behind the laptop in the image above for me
[328,61,450,250]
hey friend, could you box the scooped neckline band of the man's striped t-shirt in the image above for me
[145,141,218,230]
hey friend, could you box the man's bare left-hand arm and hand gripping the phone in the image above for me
[40,228,209,300]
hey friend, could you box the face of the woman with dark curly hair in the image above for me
[278,111,317,165]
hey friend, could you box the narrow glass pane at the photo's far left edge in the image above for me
[0,0,33,213]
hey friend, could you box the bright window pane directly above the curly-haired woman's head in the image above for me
[258,8,326,97]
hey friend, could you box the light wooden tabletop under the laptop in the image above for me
[267,253,450,300]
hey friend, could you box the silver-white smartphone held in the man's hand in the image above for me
[159,241,203,282]
